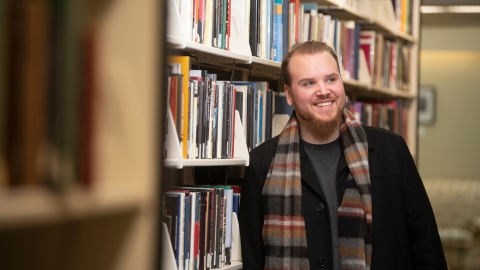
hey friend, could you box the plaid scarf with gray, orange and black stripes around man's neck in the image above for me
[262,109,373,270]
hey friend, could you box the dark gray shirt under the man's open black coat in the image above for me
[302,138,342,270]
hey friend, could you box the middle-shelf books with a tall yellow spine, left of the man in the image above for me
[166,56,274,159]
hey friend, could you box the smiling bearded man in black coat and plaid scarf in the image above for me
[240,41,447,270]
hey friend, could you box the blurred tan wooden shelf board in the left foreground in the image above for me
[0,186,142,229]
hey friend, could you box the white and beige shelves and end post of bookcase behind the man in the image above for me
[163,0,420,269]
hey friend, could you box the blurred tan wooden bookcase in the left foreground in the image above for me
[0,0,165,270]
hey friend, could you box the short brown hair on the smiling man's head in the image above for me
[282,40,340,87]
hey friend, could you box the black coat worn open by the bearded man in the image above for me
[239,126,447,270]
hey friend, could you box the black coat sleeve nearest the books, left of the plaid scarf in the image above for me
[239,160,265,270]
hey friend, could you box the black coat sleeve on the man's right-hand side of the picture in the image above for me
[400,139,447,270]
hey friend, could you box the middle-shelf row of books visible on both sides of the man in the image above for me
[167,56,407,159]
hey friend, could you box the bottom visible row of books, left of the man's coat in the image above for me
[162,185,241,270]
